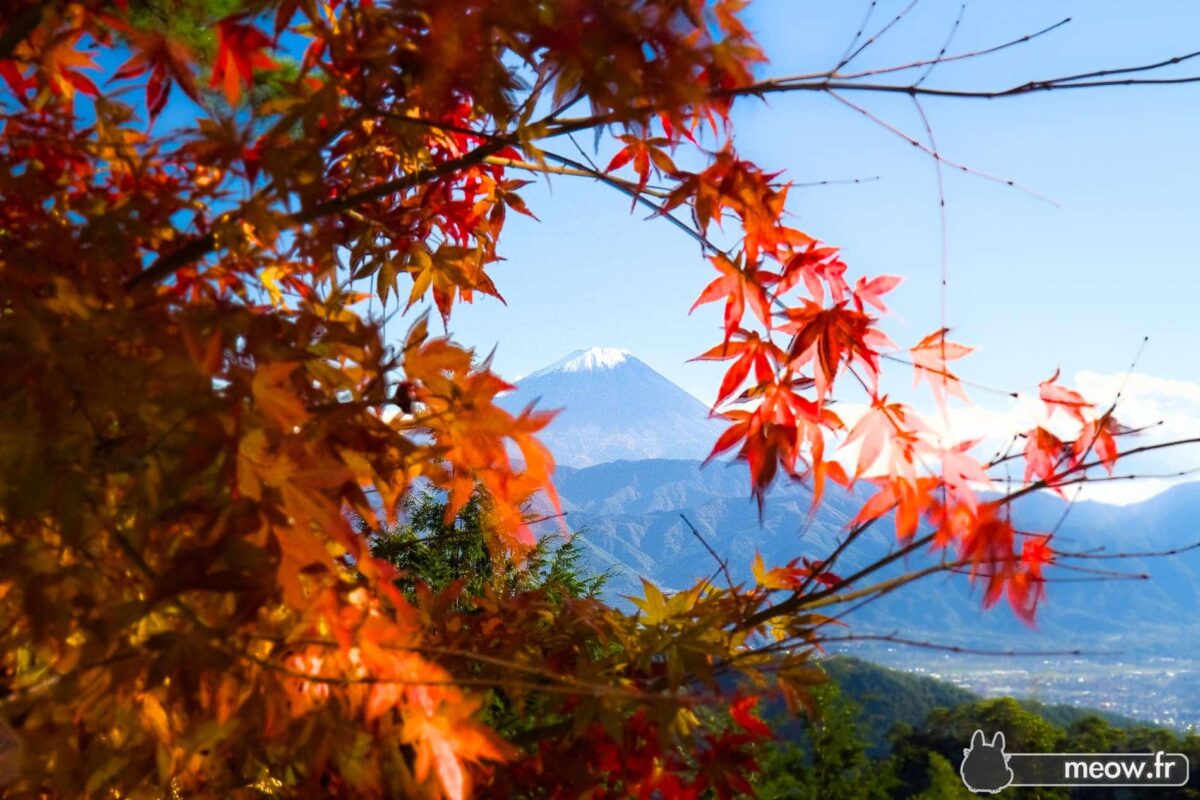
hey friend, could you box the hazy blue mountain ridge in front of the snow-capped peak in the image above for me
[557,459,1200,656]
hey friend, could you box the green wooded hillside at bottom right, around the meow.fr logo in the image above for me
[754,656,1200,800]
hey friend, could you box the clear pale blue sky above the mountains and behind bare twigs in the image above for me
[420,0,1200,501]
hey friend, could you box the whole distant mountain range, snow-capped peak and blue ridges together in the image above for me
[516,348,1200,656]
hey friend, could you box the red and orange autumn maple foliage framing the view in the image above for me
[0,0,1176,800]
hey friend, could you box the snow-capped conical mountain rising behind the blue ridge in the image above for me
[499,347,725,467]
